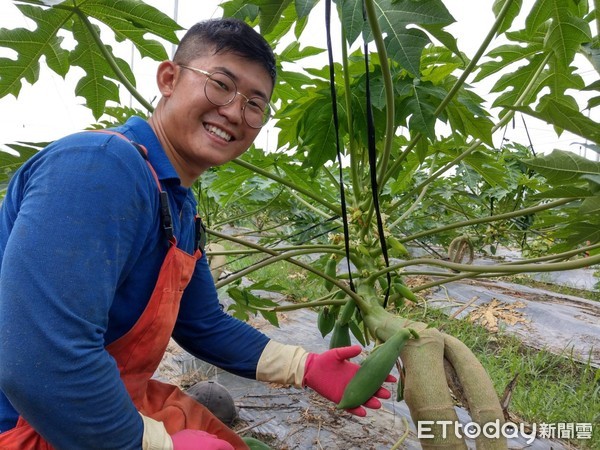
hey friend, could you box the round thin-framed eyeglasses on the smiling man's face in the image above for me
[179,64,271,129]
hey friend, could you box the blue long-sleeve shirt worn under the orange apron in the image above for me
[0,118,268,449]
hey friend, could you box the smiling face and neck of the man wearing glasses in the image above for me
[152,49,273,184]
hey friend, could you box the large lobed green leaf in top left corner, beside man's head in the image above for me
[0,0,181,118]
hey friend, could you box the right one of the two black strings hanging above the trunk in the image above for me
[363,2,392,308]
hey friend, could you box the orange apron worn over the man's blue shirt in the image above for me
[0,134,248,450]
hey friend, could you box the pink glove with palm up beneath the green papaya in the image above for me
[302,345,396,417]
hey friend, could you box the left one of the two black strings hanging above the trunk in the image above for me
[325,0,356,292]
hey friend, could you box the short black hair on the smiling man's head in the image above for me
[173,18,277,85]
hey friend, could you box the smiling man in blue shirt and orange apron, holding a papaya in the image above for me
[0,19,392,450]
